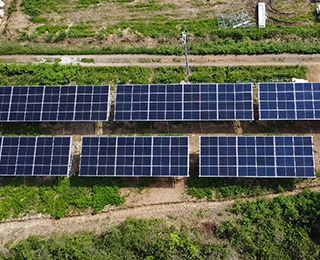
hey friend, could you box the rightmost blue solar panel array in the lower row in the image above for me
[200,136,315,178]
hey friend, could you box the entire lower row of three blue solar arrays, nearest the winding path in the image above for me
[0,136,315,178]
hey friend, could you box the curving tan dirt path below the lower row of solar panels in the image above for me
[0,182,320,251]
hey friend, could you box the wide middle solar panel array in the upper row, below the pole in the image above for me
[115,84,253,121]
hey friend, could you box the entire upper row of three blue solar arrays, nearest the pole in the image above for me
[0,83,320,122]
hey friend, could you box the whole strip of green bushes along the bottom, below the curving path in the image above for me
[2,190,320,260]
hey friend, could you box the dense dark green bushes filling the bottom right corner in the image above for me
[218,190,320,260]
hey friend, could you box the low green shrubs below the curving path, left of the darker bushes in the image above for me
[0,218,230,260]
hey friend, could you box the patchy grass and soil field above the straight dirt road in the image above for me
[0,0,320,55]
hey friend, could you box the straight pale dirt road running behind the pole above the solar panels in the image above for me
[0,54,320,67]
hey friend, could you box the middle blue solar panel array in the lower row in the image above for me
[79,136,189,177]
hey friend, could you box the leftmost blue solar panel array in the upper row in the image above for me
[0,86,111,122]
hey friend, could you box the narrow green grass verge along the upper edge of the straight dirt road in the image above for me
[4,36,320,55]
